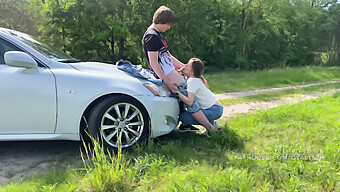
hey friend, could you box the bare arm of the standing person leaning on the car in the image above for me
[148,51,178,93]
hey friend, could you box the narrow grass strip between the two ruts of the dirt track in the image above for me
[220,83,340,106]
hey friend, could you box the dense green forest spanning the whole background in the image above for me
[0,0,340,71]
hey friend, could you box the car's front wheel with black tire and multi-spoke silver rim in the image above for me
[89,95,149,150]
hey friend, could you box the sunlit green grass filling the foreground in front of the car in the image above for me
[0,93,340,192]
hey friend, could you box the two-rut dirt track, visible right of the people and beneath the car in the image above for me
[0,81,340,184]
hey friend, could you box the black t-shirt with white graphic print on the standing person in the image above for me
[142,26,174,74]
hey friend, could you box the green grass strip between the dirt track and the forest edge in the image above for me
[205,66,340,93]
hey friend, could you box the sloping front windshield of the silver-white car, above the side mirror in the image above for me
[7,30,80,63]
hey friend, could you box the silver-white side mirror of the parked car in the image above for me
[4,51,38,72]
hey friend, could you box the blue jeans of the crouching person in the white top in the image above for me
[179,105,223,125]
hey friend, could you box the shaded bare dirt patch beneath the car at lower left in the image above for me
[0,141,81,184]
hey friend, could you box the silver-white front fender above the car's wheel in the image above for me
[53,69,153,133]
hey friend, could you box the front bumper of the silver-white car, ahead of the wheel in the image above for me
[136,96,179,138]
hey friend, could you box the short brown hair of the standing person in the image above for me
[153,5,175,24]
